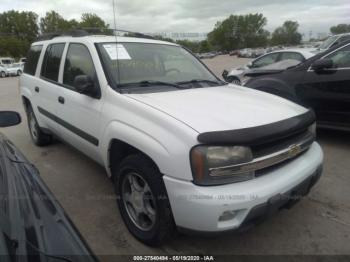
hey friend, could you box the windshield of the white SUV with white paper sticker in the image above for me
[97,43,218,87]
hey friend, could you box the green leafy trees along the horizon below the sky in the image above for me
[0,10,350,58]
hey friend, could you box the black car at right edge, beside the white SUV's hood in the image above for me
[245,41,350,130]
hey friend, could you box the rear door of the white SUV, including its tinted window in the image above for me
[34,43,65,134]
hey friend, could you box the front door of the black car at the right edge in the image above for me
[296,44,350,128]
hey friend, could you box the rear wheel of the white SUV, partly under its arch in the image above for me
[27,105,52,146]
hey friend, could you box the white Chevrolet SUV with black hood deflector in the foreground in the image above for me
[20,33,323,245]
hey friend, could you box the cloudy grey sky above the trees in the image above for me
[0,0,350,36]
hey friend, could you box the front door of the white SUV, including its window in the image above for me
[57,43,102,161]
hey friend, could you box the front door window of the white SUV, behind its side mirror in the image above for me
[63,44,98,89]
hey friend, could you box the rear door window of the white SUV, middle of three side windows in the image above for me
[41,43,65,82]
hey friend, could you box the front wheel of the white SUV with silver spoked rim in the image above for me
[114,154,175,246]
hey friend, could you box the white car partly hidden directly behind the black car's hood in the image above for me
[222,49,315,85]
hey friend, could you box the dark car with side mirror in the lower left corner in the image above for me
[0,111,97,262]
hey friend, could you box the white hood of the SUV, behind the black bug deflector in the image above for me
[127,84,307,133]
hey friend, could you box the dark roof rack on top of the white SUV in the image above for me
[36,27,154,41]
